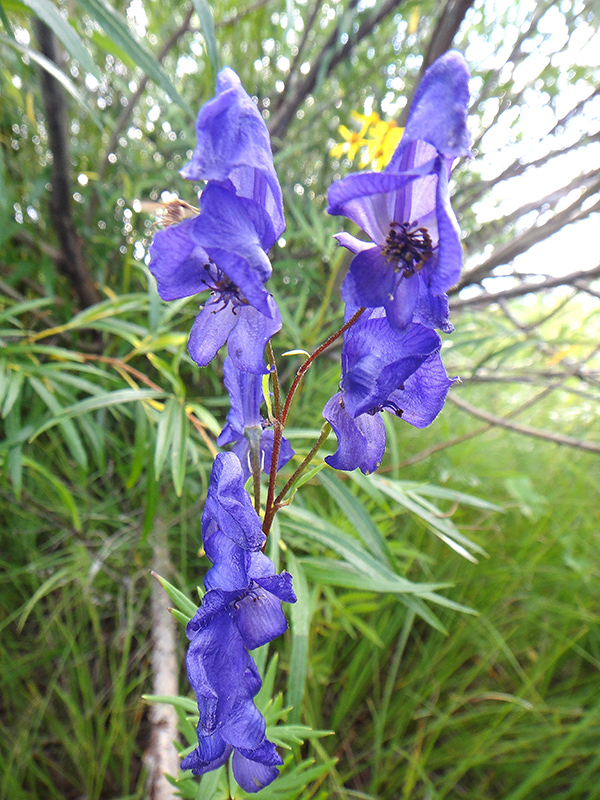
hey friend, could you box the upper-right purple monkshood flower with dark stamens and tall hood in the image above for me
[328,52,470,332]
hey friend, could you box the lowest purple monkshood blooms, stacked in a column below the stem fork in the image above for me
[181,453,296,792]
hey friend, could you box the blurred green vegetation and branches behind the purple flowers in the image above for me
[0,0,600,800]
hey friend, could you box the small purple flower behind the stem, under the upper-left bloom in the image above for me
[217,357,294,481]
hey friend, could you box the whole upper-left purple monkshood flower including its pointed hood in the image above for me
[150,69,285,373]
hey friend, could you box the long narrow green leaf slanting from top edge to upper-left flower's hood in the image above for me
[77,0,193,116]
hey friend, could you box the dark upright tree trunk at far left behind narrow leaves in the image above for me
[33,17,101,308]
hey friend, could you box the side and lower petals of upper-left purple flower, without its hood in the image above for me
[150,184,281,373]
